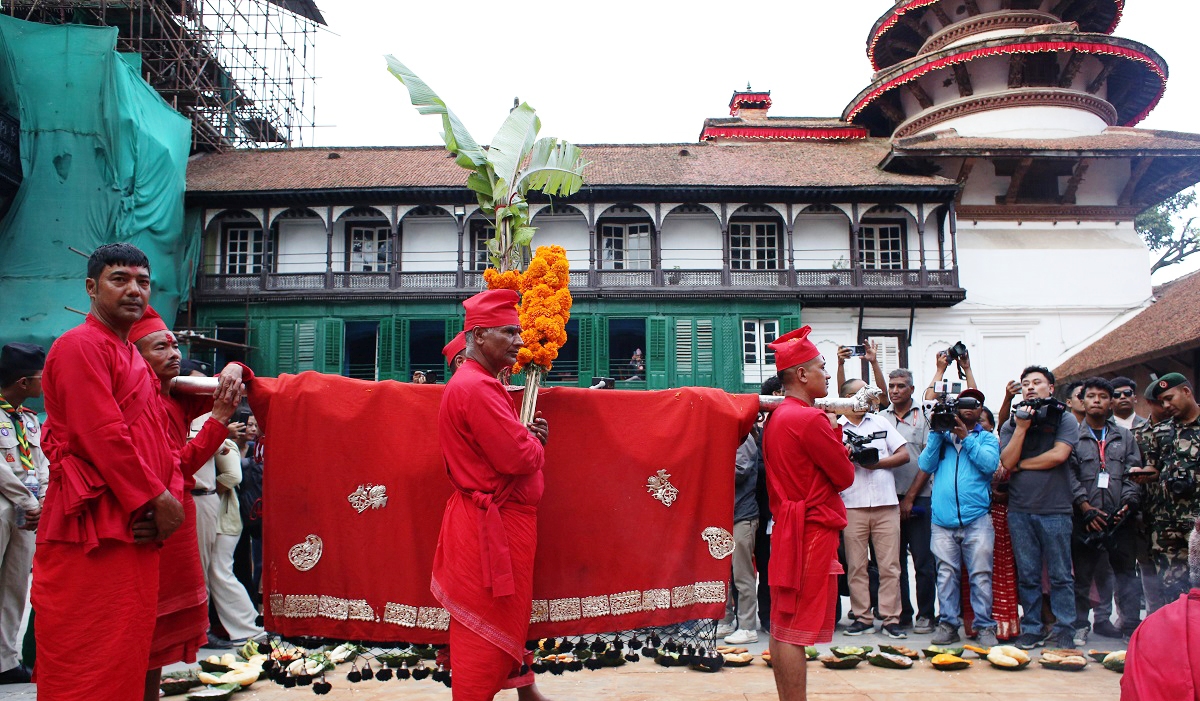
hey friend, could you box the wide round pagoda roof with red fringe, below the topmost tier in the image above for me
[842,31,1168,136]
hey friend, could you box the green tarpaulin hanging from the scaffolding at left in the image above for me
[0,16,200,347]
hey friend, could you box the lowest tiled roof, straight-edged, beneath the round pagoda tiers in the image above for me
[895,126,1200,156]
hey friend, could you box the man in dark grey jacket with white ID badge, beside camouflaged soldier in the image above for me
[1070,377,1141,646]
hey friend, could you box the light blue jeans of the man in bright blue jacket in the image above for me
[932,514,996,630]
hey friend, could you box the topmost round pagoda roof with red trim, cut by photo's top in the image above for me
[866,0,1124,71]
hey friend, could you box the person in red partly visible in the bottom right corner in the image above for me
[1121,519,1200,701]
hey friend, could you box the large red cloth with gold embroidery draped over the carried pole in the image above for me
[250,373,758,642]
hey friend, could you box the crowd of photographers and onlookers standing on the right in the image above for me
[716,343,1200,649]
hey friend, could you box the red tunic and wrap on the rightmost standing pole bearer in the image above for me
[762,397,854,645]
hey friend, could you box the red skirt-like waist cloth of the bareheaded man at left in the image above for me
[31,541,158,701]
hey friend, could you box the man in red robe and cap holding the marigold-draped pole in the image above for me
[430,289,550,701]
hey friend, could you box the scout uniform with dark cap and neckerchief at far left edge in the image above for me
[0,343,50,671]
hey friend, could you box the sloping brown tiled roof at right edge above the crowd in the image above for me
[1054,271,1200,379]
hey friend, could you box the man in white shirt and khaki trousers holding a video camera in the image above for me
[839,379,908,639]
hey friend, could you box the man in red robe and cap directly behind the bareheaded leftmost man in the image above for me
[130,307,253,701]
